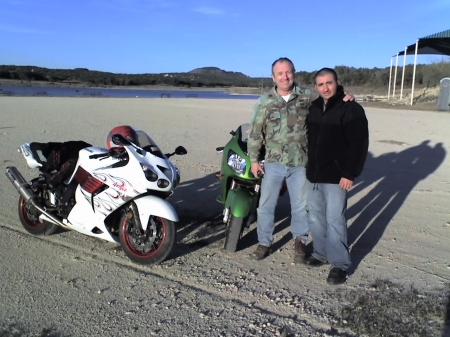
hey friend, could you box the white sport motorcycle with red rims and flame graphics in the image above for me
[5,126,187,264]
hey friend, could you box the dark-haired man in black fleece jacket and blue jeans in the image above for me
[306,68,369,284]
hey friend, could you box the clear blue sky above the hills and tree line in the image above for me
[0,0,450,77]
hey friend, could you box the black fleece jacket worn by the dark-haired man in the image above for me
[306,86,369,184]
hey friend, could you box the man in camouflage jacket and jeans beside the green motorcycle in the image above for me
[247,58,312,263]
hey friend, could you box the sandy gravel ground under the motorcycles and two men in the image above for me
[0,97,450,336]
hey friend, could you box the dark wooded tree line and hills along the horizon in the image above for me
[0,59,450,88]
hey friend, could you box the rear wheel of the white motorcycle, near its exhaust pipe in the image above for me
[18,197,58,235]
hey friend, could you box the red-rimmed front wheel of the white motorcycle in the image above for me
[119,213,176,265]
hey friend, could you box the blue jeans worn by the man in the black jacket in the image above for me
[307,181,351,270]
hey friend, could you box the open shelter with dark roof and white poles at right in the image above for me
[388,29,450,105]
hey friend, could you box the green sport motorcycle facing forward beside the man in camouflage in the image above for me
[216,124,264,252]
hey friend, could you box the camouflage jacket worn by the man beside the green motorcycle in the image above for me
[247,85,313,167]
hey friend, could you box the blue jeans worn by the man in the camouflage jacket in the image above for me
[257,163,309,247]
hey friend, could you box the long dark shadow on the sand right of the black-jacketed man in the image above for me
[347,141,446,273]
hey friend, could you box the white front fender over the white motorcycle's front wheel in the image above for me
[133,195,179,231]
